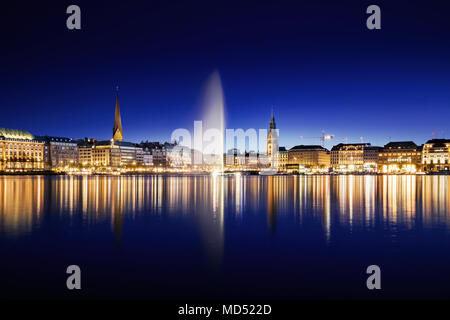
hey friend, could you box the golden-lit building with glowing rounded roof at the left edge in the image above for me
[0,128,45,170]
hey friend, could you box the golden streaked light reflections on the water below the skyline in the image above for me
[0,175,450,242]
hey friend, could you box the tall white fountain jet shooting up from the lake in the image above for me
[203,71,225,173]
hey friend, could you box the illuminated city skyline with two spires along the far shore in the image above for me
[0,95,450,175]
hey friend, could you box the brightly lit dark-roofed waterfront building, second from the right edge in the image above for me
[378,141,422,173]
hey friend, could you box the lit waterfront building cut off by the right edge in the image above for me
[422,139,450,172]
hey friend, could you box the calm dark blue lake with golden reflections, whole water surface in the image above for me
[0,176,450,299]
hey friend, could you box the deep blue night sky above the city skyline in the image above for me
[0,0,450,147]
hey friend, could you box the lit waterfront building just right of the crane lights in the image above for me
[331,143,382,173]
